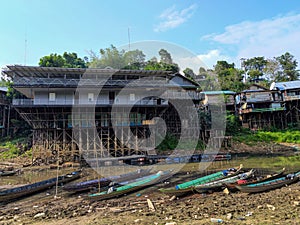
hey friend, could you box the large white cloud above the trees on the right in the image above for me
[202,14,300,65]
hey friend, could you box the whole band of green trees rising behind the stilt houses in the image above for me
[39,45,299,92]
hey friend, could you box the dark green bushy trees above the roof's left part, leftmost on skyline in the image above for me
[39,52,87,68]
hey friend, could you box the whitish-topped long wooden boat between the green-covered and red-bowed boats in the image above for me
[194,169,255,193]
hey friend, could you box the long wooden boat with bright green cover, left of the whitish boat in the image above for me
[159,164,243,197]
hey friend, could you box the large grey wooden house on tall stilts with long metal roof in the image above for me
[4,65,200,161]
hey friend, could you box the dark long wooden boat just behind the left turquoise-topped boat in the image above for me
[63,169,151,192]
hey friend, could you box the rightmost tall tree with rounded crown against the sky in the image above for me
[276,52,299,81]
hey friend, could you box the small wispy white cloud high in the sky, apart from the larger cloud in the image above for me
[154,4,197,32]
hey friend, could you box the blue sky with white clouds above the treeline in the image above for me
[0,0,300,72]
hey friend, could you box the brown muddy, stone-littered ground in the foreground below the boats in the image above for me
[0,142,300,225]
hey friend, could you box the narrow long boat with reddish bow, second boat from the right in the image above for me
[225,168,285,192]
